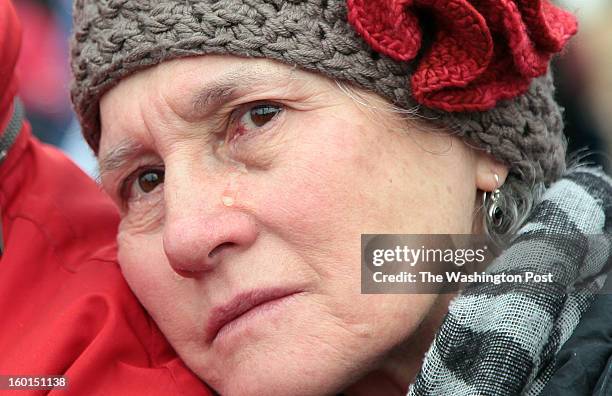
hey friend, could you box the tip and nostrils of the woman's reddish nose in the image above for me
[163,207,257,277]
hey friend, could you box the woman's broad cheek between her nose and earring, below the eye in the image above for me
[242,118,475,254]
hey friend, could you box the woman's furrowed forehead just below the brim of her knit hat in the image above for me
[98,55,333,159]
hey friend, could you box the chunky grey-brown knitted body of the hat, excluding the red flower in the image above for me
[71,0,571,183]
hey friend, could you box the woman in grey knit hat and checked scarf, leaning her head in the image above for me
[72,0,610,395]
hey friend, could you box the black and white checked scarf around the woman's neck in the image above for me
[408,168,612,396]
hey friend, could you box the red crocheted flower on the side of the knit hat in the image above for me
[347,0,578,111]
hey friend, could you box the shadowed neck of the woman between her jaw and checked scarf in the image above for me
[343,294,455,396]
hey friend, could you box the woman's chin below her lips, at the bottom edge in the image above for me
[194,328,367,396]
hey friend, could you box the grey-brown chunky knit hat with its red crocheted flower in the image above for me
[72,0,577,183]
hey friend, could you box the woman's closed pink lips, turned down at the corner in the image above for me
[206,289,300,343]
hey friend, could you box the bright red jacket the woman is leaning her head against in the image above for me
[0,0,211,396]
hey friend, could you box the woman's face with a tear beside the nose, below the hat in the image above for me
[99,56,490,395]
